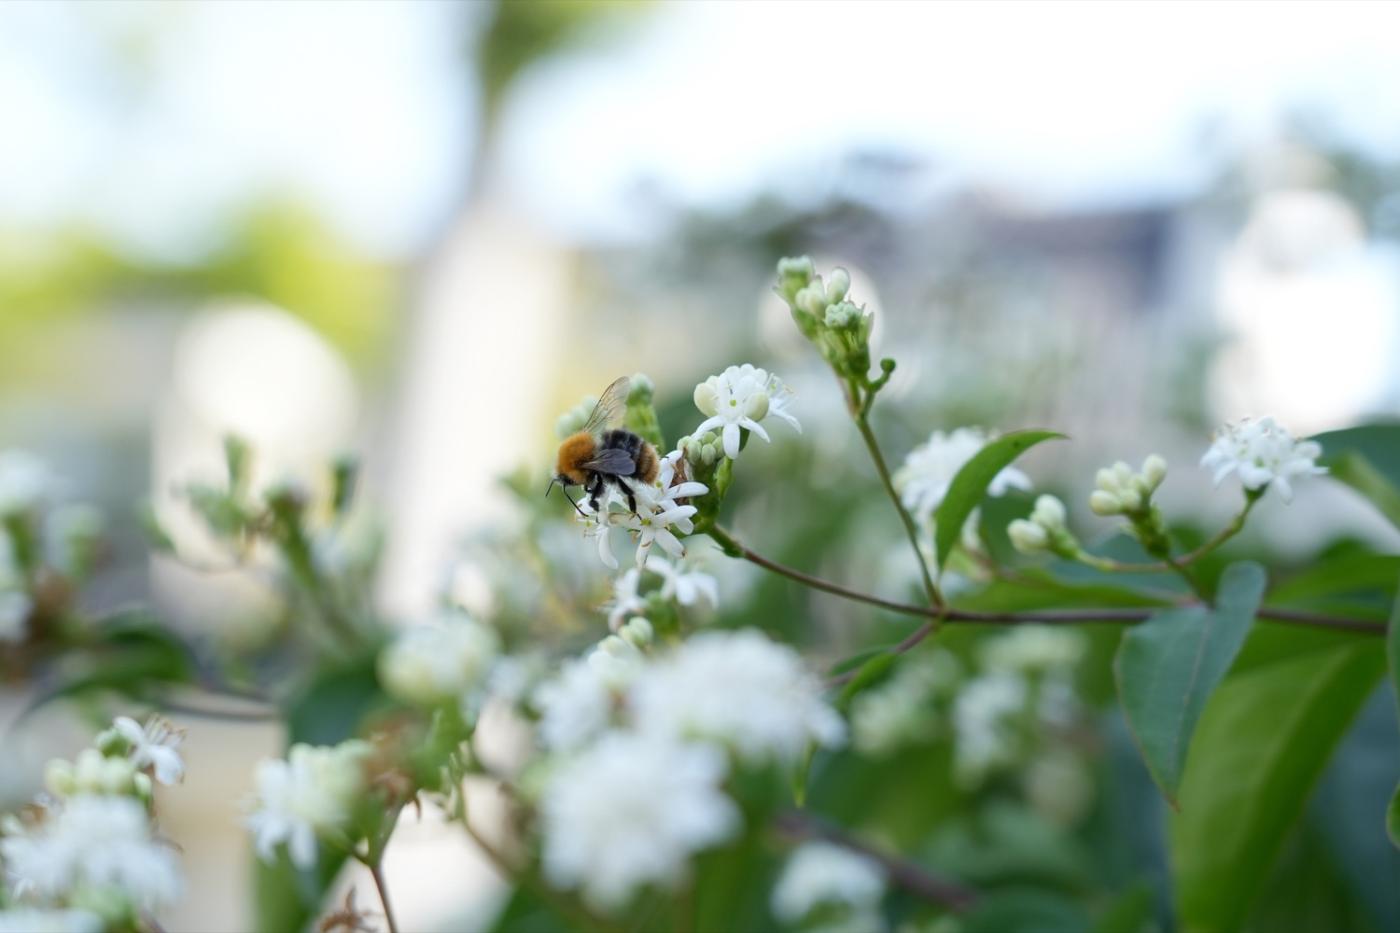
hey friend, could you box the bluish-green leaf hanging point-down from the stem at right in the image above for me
[1113,554,1264,807]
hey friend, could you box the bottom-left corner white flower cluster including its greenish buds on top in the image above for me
[0,717,185,929]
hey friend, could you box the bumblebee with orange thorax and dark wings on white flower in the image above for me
[545,375,661,514]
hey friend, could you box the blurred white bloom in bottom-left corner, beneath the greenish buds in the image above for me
[0,794,181,909]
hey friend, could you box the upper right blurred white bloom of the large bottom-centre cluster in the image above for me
[630,629,846,762]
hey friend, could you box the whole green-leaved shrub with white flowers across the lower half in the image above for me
[0,259,1400,933]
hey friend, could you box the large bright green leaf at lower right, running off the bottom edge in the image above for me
[1170,643,1385,933]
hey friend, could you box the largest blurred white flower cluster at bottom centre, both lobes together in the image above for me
[535,630,844,908]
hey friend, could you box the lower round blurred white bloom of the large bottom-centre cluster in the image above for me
[540,733,739,908]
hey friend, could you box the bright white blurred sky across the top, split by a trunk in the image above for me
[0,1,1400,255]
